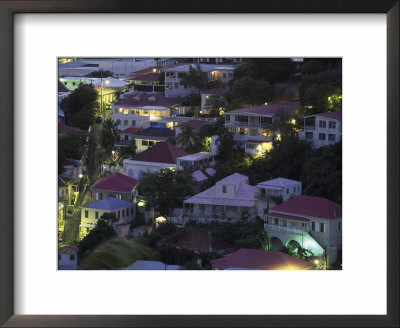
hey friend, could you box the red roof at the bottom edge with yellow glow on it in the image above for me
[212,248,311,270]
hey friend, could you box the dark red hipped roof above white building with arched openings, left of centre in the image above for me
[132,142,189,164]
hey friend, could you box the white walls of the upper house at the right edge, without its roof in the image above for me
[299,116,342,148]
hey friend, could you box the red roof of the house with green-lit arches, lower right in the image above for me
[271,195,342,219]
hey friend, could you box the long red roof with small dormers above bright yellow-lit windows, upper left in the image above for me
[115,92,179,108]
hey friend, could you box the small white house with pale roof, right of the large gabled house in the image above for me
[256,178,301,212]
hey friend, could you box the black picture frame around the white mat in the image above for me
[0,0,400,327]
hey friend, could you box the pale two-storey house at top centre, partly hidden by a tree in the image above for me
[163,63,235,98]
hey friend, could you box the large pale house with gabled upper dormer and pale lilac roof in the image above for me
[183,173,258,222]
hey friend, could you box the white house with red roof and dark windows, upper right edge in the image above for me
[299,111,342,148]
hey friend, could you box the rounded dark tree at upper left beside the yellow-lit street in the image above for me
[61,83,98,130]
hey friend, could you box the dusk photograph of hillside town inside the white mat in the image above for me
[57,58,342,270]
